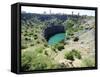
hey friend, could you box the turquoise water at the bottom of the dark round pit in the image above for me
[48,33,65,45]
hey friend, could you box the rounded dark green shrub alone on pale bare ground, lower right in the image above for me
[65,49,81,61]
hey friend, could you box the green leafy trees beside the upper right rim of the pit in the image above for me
[63,18,84,39]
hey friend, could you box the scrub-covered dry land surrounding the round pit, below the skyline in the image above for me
[21,14,95,71]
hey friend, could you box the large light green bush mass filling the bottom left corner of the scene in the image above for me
[21,49,55,71]
